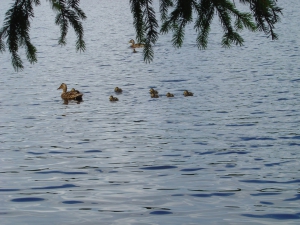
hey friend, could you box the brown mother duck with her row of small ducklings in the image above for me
[57,83,194,102]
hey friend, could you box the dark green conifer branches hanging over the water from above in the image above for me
[0,0,282,71]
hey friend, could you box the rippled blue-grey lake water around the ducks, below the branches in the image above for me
[0,0,300,225]
